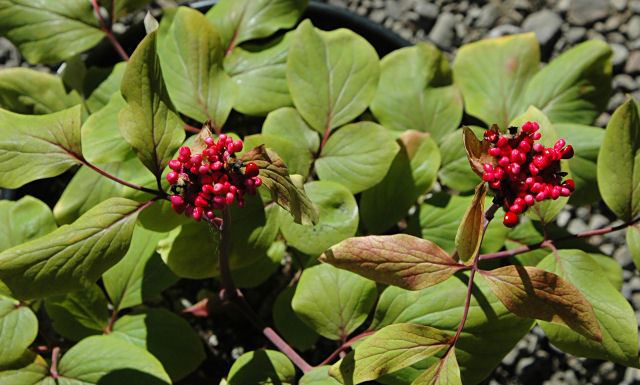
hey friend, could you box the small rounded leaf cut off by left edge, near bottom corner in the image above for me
[0,295,38,364]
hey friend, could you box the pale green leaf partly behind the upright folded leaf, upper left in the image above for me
[81,92,133,165]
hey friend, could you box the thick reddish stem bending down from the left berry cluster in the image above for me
[218,208,313,373]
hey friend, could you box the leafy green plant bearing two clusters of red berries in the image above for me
[0,0,640,385]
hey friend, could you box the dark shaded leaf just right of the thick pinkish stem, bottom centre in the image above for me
[272,287,319,351]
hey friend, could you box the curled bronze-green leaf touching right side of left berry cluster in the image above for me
[241,145,318,224]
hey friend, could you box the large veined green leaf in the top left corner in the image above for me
[0,0,104,64]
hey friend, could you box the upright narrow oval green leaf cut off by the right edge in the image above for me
[598,99,640,221]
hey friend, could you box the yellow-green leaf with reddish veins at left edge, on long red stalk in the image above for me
[0,106,82,188]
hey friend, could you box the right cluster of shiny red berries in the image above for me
[482,122,575,227]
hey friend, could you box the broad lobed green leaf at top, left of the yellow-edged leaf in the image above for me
[371,43,462,141]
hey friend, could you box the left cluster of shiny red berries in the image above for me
[167,134,262,226]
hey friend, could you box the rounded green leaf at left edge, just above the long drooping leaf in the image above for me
[0,196,58,251]
